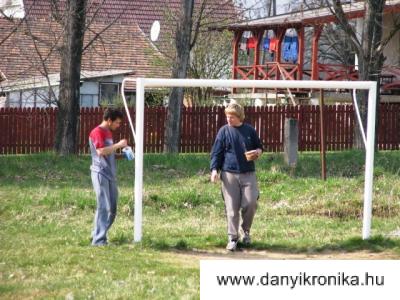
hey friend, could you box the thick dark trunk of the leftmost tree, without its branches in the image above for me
[54,0,87,155]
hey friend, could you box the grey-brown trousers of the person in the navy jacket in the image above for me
[221,171,259,240]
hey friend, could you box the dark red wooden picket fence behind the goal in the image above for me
[0,104,400,154]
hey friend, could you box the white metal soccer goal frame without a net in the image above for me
[121,78,377,242]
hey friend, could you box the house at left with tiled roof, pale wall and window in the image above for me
[0,0,234,107]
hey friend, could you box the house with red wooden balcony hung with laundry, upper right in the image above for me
[216,0,400,104]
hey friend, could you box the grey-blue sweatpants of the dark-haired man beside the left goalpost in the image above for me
[91,172,118,245]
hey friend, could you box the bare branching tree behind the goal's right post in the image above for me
[304,0,400,148]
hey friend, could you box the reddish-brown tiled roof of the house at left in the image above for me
[0,0,235,80]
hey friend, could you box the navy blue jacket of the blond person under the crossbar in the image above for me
[210,123,262,173]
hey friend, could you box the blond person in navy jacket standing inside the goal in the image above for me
[210,103,262,251]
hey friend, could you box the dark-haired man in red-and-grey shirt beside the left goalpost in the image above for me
[89,108,127,246]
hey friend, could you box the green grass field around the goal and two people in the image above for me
[0,151,400,299]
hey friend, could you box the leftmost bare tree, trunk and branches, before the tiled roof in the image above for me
[0,0,128,155]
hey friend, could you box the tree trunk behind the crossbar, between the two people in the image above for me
[164,0,194,153]
